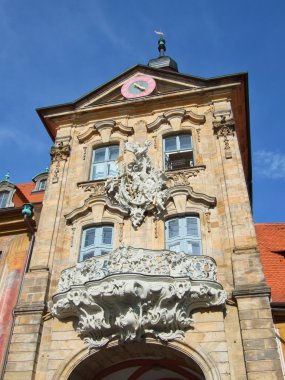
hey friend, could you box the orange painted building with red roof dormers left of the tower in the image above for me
[0,172,48,372]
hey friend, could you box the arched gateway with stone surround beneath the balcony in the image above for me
[54,339,217,380]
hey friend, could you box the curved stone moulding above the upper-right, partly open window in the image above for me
[146,109,206,132]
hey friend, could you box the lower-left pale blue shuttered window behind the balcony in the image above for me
[80,225,113,261]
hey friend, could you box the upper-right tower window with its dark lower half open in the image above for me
[163,134,194,170]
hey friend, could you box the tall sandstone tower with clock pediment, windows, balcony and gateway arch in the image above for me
[1,57,282,380]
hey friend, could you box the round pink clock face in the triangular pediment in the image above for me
[121,75,156,99]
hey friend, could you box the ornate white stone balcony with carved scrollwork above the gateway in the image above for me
[51,247,226,348]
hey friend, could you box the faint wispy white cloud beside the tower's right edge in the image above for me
[253,150,285,179]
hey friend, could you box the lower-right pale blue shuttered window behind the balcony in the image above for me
[163,216,202,255]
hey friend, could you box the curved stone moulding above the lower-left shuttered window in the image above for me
[64,195,128,225]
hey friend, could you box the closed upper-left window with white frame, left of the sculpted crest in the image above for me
[90,145,119,179]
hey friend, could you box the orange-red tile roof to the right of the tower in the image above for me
[255,223,285,302]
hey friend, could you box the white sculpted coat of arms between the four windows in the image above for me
[105,141,168,227]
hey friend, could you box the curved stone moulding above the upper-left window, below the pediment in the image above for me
[77,120,134,144]
